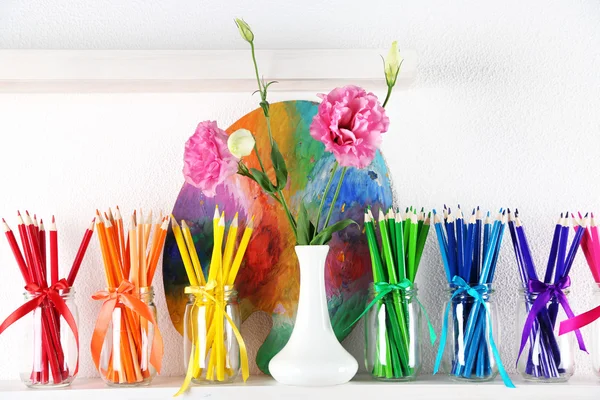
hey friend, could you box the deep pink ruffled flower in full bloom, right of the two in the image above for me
[310,86,390,168]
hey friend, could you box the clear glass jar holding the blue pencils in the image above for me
[444,284,501,382]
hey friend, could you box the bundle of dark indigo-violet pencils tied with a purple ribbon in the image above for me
[508,210,584,379]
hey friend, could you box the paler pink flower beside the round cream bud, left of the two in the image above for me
[183,121,238,197]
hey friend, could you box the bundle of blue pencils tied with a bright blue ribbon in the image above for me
[434,205,512,386]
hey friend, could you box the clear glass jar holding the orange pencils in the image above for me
[100,287,158,387]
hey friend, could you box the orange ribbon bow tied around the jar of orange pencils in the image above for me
[91,280,163,373]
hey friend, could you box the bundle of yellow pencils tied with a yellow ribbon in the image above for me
[171,206,254,394]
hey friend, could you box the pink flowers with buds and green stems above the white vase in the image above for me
[183,19,402,245]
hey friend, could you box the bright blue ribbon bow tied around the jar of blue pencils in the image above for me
[433,276,515,388]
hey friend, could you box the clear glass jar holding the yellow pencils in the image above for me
[183,286,241,383]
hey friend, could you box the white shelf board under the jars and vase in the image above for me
[0,376,600,400]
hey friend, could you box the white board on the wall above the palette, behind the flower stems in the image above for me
[0,49,417,93]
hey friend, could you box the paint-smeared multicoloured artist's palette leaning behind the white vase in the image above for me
[163,101,392,373]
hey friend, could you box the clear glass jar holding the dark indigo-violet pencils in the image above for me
[517,288,575,382]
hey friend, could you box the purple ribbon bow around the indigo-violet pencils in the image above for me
[517,276,587,362]
